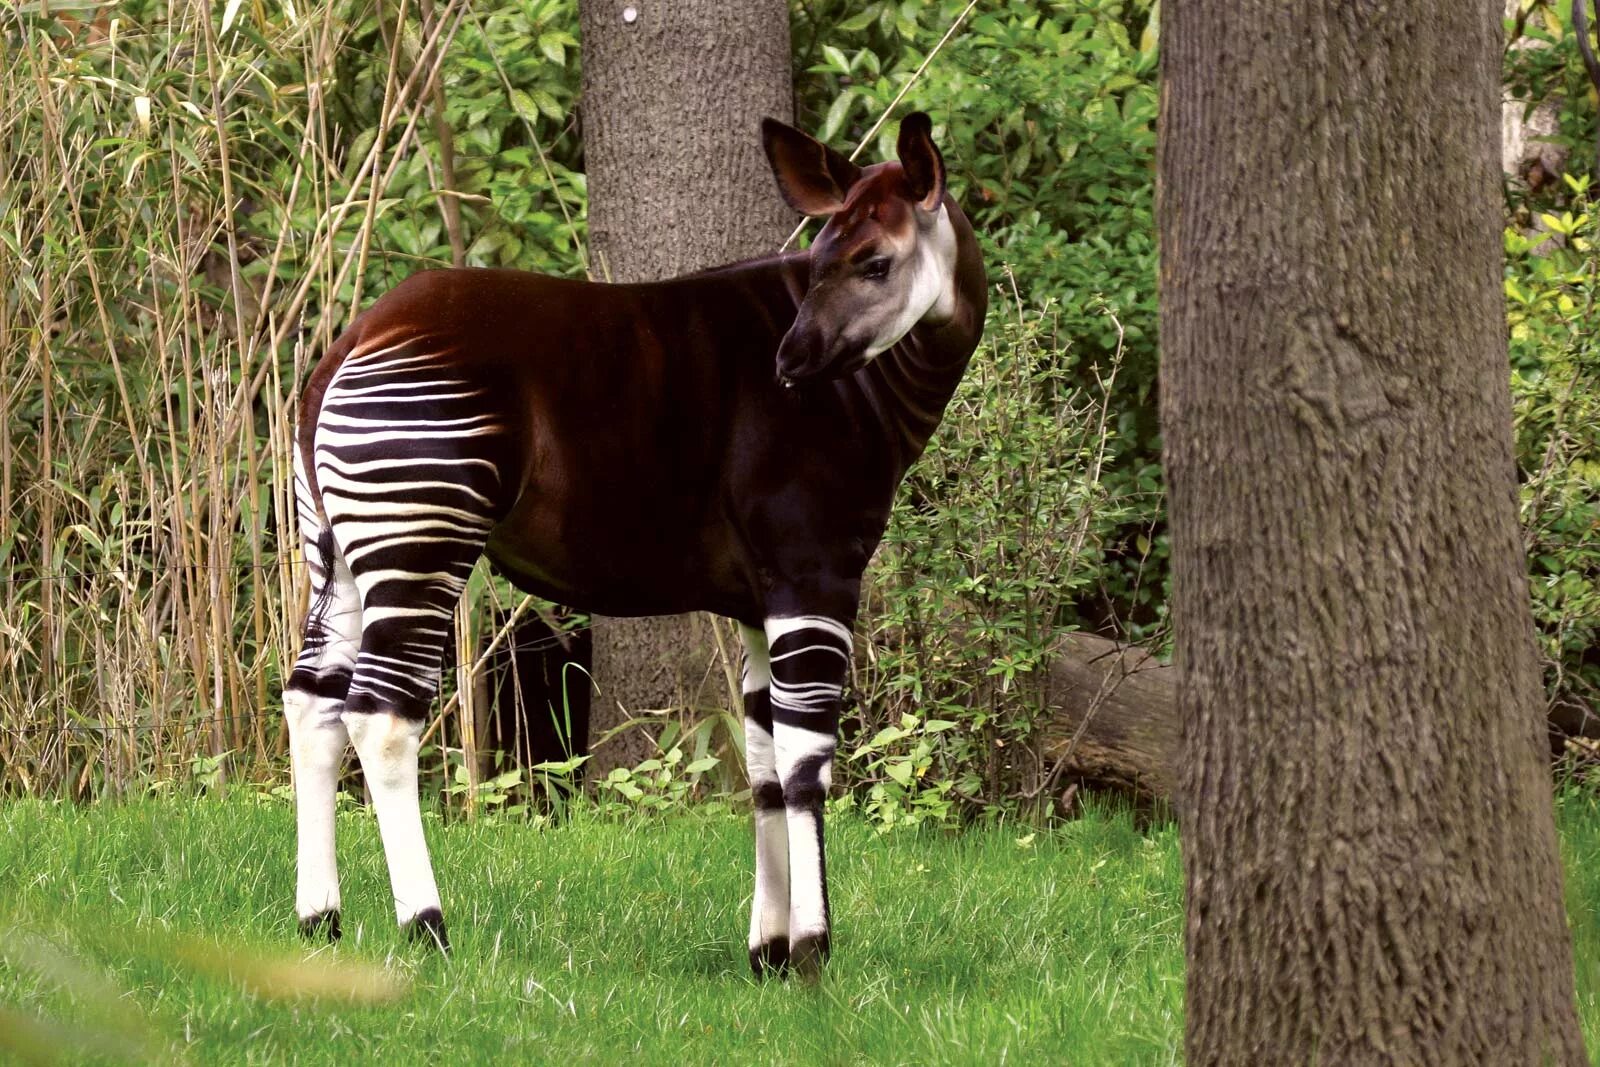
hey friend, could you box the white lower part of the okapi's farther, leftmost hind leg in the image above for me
[283,689,349,918]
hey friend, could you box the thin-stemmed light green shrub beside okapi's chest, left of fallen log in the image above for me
[840,287,1147,825]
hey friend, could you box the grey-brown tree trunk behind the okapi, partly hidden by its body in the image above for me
[579,0,792,773]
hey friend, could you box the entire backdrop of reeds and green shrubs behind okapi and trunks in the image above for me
[0,0,1600,825]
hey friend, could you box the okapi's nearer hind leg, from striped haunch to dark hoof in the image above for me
[315,349,502,949]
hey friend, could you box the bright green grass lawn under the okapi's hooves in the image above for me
[0,795,1600,1067]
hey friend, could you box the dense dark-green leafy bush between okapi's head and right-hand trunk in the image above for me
[795,0,1166,652]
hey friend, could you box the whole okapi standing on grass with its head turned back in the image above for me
[283,112,987,976]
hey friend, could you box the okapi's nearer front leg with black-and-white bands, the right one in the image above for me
[766,614,850,977]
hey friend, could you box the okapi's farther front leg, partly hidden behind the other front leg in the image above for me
[739,625,789,977]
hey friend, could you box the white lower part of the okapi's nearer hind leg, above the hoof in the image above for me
[344,712,438,923]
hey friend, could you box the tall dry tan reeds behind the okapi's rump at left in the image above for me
[0,0,508,797]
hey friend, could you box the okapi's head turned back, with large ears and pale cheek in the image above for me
[762,112,955,386]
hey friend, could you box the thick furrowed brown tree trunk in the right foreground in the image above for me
[1158,0,1586,1065]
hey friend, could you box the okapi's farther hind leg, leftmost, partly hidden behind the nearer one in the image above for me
[283,450,362,939]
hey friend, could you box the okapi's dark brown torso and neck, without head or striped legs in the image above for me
[301,200,986,625]
